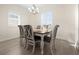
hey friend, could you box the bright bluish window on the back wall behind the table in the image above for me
[41,11,53,25]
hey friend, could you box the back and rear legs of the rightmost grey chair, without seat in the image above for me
[50,25,59,54]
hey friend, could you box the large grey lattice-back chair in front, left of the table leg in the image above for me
[24,25,40,54]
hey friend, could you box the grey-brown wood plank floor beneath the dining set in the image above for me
[0,38,79,55]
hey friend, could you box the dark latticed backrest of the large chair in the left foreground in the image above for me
[24,25,34,43]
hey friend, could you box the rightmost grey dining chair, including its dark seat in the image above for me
[44,25,59,54]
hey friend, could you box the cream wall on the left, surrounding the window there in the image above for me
[0,4,27,41]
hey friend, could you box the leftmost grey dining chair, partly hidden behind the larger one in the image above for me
[18,25,26,48]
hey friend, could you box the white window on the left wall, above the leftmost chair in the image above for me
[8,12,20,26]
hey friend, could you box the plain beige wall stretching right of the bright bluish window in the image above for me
[54,5,76,43]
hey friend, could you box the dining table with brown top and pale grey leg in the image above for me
[33,29,52,55]
